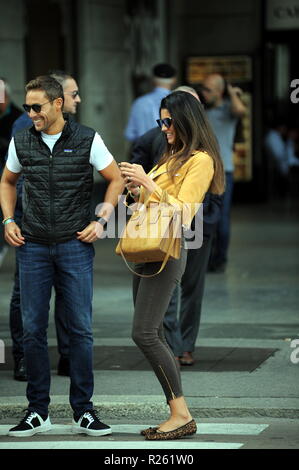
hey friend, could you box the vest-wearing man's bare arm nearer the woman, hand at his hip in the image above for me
[77,160,125,243]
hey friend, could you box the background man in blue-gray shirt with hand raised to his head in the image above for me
[202,74,246,272]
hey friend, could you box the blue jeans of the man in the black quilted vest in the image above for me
[18,240,94,418]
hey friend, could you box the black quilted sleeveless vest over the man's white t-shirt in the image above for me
[14,120,95,245]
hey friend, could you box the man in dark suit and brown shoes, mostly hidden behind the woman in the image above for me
[131,86,222,366]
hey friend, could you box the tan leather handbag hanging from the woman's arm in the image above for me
[115,191,182,277]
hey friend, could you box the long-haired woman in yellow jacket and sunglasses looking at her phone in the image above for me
[120,91,224,440]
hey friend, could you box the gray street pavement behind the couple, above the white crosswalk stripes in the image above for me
[0,198,299,424]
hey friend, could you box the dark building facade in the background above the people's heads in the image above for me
[0,0,299,200]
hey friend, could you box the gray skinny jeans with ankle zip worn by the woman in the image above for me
[132,247,187,402]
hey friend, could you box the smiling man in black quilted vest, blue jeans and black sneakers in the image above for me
[0,76,123,437]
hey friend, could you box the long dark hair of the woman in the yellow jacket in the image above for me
[158,91,224,194]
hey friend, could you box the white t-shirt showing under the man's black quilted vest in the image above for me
[6,132,113,173]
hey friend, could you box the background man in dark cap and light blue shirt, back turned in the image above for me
[125,64,176,142]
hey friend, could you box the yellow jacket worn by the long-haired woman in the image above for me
[139,151,214,227]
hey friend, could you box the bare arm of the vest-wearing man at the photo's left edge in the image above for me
[0,166,25,247]
